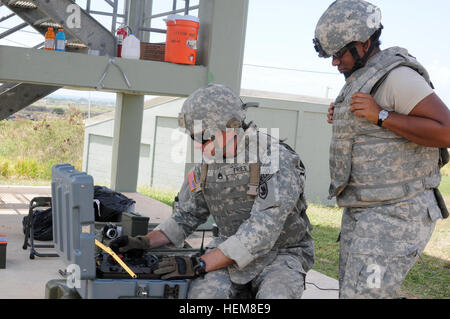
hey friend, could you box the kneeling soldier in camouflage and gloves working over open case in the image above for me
[111,84,314,299]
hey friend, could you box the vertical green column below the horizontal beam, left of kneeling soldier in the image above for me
[111,93,144,192]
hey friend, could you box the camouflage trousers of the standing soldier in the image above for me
[339,191,441,299]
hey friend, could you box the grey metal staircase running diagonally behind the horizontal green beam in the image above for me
[0,0,115,120]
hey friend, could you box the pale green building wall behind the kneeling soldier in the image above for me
[83,90,334,205]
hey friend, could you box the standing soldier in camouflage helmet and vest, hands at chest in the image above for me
[314,0,450,298]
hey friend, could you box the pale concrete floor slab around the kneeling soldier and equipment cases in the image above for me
[0,186,338,299]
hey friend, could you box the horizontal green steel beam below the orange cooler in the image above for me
[0,46,208,96]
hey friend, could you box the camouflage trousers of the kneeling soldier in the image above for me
[188,254,305,299]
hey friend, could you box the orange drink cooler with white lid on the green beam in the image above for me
[164,14,200,64]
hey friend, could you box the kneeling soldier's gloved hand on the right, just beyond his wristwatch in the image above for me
[153,256,205,280]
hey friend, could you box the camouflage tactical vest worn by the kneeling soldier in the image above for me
[199,144,311,249]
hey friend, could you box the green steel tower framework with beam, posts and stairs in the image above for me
[0,0,249,192]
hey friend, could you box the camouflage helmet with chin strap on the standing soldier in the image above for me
[313,0,382,58]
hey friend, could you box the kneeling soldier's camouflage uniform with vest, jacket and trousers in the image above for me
[157,125,314,298]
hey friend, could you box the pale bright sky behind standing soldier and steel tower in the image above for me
[0,0,450,106]
